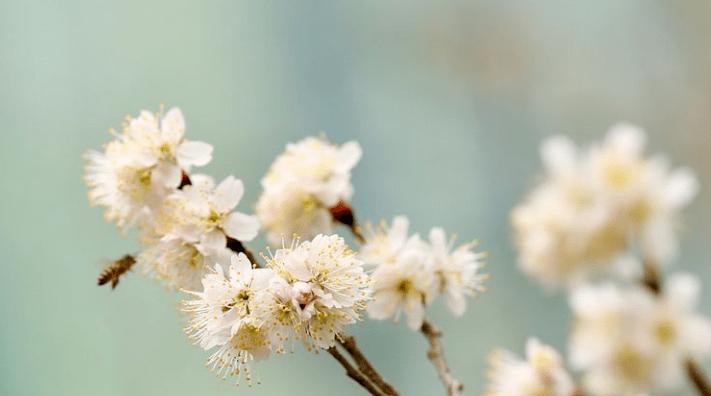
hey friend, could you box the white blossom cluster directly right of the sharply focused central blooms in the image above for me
[360,216,487,330]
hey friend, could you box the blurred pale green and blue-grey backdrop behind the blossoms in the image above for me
[0,0,711,396]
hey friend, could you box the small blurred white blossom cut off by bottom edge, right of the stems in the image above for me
[484,338,576,396]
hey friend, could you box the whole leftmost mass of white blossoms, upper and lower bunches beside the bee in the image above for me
[85,108,259,289]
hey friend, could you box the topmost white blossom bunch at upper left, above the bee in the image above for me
[84,109,212,228]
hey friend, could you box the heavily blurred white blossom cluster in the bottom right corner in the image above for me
[570,275,711,396]
